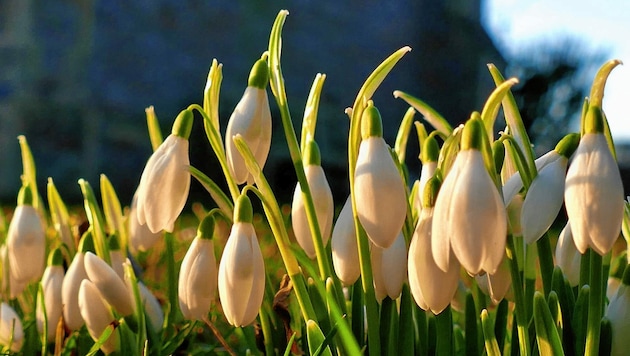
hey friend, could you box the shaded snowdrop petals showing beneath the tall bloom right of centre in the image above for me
[370,232,407,300]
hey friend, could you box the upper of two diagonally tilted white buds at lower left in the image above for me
[84,252,134,316]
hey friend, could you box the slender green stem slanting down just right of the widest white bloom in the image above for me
[506,235,531,356]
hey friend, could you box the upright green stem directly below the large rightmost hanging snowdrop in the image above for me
[584,251,602,356]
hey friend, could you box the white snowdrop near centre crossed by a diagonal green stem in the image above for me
[291,140,335,258]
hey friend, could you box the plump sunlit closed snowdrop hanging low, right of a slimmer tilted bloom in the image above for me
[218,195,265,327]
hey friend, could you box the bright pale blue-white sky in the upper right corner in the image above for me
[484,0,630,141]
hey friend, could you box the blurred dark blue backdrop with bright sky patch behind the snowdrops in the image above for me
[0,0,630,205]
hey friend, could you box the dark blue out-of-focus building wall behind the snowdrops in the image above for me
[0,0,504,203]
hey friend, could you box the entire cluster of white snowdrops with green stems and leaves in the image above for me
[0,11,630,355]
